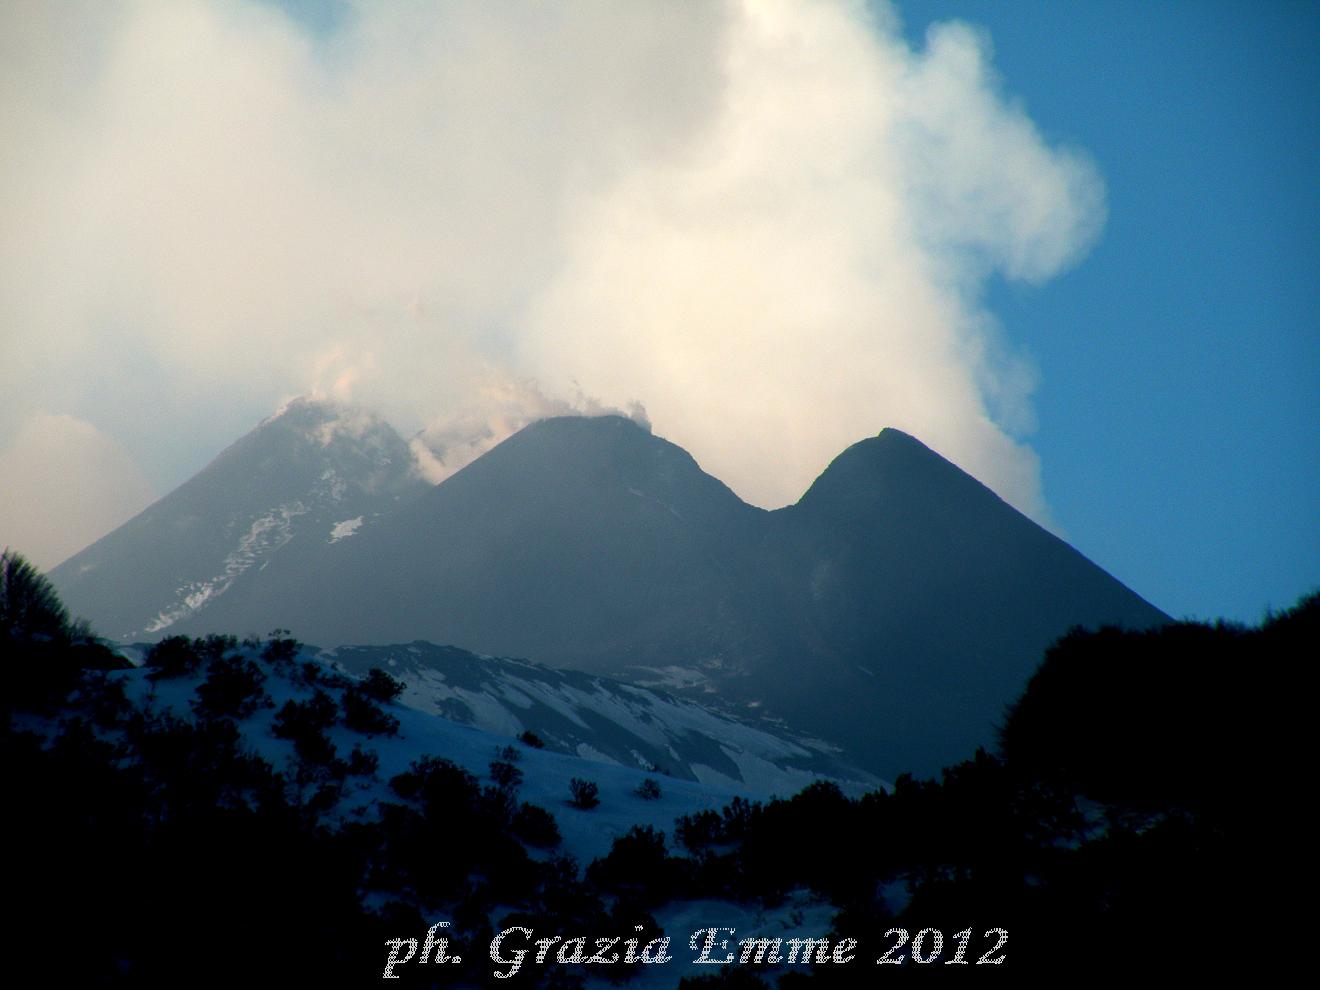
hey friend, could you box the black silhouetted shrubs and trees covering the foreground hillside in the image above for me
[0,553,1320,989]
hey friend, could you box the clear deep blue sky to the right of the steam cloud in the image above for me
[899,0,1320,620]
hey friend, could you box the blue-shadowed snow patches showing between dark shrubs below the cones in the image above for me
[79,644,855,990]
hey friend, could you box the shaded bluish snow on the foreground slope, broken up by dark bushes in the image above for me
[72,644,855,990]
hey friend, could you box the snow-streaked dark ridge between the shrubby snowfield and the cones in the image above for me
[317,642,882,796]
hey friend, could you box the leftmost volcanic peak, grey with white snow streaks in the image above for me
[50,399,429,642]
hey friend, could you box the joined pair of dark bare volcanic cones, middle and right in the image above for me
[53,403,1167,779]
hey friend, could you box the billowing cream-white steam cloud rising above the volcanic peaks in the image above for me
[0,0,1104,562]
